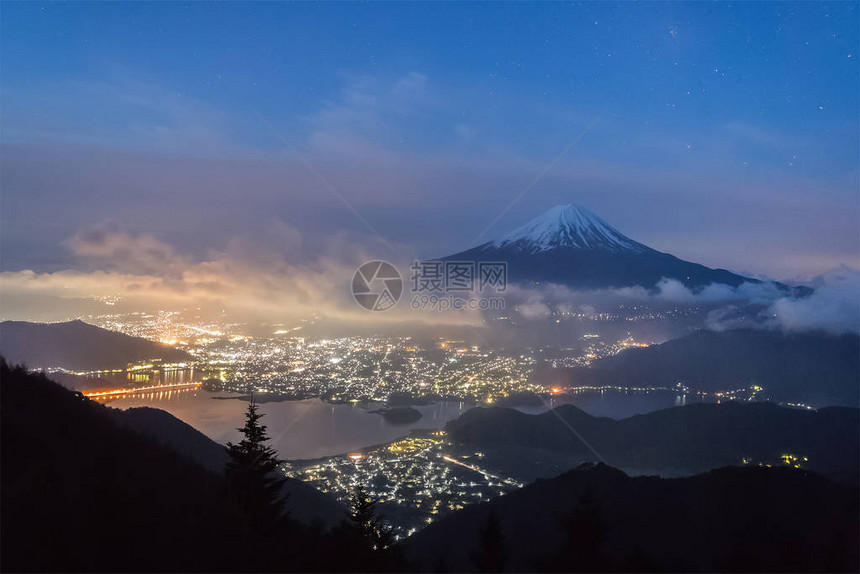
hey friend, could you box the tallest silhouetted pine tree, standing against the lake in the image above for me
[224,397,286,533]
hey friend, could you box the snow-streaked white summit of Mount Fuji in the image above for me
[492,204,648,253]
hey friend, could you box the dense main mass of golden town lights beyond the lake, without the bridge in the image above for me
[69,312,620,403]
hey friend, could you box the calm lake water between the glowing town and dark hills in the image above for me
[107,389,692,460]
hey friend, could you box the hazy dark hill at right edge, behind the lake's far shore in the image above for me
[570,329,860,407]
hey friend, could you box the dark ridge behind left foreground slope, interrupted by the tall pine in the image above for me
[107,407,347,528]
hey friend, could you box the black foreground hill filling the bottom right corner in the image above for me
[404,465,858,572]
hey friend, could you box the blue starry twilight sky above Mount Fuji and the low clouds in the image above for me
[0,2,860,310]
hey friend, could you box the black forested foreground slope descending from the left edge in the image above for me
[0,360,372,572]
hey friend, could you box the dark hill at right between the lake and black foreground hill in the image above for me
[446,402,860,483]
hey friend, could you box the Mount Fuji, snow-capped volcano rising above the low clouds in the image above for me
[442,204,799,294]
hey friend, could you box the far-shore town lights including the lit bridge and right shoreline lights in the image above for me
[55,307,780,408]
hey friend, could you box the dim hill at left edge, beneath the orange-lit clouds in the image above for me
[0,320,192,371]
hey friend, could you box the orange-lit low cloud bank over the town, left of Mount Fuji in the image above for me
[0,220,490,325]
